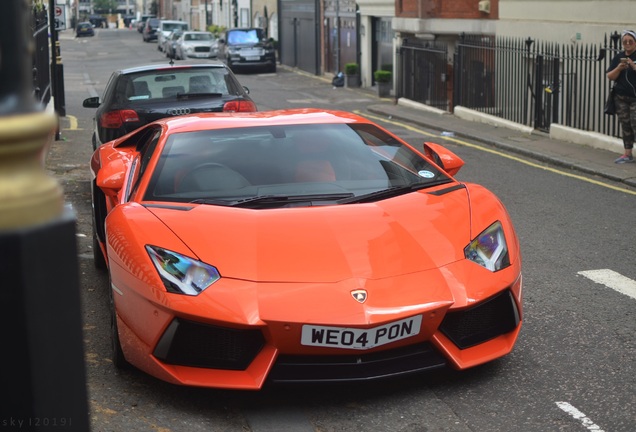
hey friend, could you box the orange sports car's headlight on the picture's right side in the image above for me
[464,221,510,272]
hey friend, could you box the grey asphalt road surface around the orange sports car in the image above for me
[47,29,636,432]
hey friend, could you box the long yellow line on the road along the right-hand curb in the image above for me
[354,111,636,195]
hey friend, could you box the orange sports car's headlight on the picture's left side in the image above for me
[146,245,221,296]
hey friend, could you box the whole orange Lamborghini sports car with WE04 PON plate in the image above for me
[91,109,522,389]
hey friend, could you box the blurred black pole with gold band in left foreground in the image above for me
[0,0,90,432]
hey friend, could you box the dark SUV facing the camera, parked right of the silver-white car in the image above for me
[219,28,276,72]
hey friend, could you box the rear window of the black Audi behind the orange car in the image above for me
[116,68,237,106]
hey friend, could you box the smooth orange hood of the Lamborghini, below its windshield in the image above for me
[149,189,470,283]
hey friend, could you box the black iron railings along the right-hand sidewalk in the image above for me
[397,33,620,137]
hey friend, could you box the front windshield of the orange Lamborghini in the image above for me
[144,124,451,208]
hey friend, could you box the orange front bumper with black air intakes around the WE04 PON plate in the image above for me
[113,256,522,389]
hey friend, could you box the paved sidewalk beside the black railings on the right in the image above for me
[361,90,636,187]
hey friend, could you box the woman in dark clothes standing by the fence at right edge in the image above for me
[606,30,636,163]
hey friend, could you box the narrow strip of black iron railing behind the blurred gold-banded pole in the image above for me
[31,10,51,105]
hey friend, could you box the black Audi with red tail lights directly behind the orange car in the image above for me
[83,63,256,149]
